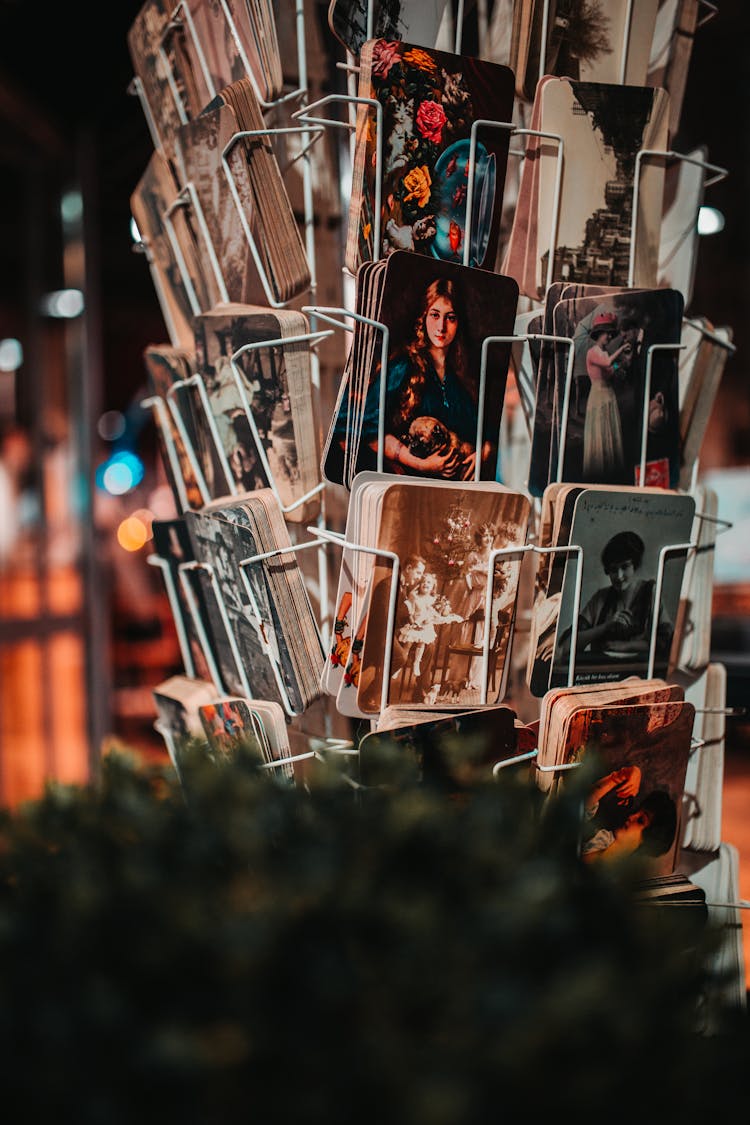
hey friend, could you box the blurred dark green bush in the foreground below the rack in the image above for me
[0,746,748,1125]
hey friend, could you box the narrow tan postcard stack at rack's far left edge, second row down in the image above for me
[130,150,219,349]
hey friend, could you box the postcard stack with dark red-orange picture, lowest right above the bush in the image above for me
[536,678,695,879]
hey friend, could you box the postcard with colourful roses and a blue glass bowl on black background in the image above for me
[346,39,514,273]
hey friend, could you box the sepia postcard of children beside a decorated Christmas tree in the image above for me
[358,482,530,712]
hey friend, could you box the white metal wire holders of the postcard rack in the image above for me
[134,0,733,805]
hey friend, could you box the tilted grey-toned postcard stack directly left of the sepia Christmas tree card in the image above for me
[184,488,324,714]
